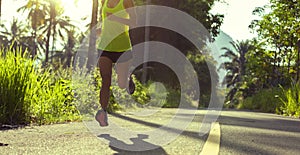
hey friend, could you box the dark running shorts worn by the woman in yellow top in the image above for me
[98,50,132,63]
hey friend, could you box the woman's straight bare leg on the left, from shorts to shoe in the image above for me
[99,57,113,111]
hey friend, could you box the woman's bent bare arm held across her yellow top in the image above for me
[107,0,136,27]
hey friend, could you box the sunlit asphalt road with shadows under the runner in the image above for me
[0,109,300,155]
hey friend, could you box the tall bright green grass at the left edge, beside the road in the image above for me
[0,47,80,124]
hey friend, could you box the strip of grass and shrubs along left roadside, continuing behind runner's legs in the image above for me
[0,49,193,126]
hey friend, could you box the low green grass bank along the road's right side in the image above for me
[236,82,300,117]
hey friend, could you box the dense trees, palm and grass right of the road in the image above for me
[222,0,300,117]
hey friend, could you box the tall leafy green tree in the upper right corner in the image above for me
[250,0,300,86]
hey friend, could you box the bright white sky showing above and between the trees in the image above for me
[1,0,269,40]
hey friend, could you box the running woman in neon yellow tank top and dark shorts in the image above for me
[95,0,136,126]
